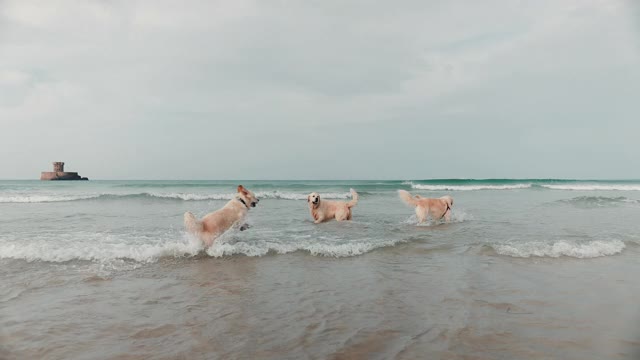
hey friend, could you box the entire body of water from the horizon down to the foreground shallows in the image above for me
[0,179,640,359]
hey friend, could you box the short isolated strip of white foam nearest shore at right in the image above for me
[492,240,625,259]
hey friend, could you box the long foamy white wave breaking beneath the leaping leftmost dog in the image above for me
[0,231,404,263]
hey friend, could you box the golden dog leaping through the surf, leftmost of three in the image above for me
[184,185,260,247]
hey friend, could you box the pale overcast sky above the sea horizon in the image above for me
[0,0,640,180]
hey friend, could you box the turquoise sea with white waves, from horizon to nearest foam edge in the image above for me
[0,179,640,263]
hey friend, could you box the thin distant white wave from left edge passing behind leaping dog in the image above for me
[0,190,356,203]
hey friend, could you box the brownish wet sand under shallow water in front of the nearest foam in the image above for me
[0,242,640,359]
